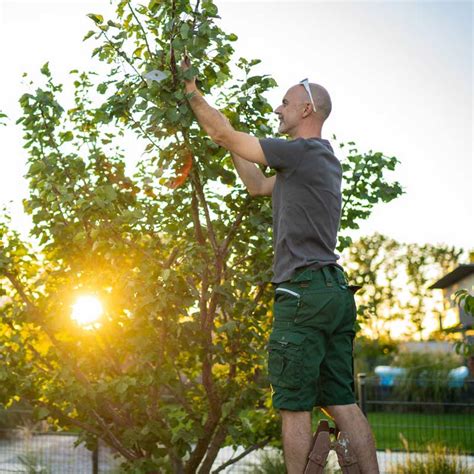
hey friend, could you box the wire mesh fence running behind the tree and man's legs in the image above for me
[0,374,474,474]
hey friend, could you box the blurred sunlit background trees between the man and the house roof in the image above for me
[343,233,462,339]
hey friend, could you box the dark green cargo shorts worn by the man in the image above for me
[268,266,356,411]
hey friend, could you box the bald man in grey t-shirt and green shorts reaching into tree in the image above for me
[182,58,379,474]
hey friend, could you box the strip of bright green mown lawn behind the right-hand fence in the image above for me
[368,413,474,453]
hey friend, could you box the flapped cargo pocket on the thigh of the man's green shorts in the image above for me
[268,331,306,389]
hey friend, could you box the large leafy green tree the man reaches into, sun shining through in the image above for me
[0,0,401,473]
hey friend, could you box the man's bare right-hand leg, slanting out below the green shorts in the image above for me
[323,403,380,474]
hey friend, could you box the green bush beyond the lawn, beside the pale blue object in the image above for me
[393,352,461,402]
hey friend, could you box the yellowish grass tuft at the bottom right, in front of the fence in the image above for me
[390,439,471,474]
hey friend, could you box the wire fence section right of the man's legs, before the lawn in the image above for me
[358,374,474,455]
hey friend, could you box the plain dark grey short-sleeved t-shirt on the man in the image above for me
[260,138,342,283]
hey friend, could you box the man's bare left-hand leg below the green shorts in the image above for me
[280,410,313,474]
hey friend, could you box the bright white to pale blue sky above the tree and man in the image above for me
[0,0,474,256]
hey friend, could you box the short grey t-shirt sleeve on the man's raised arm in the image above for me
[260,138,304,171]
